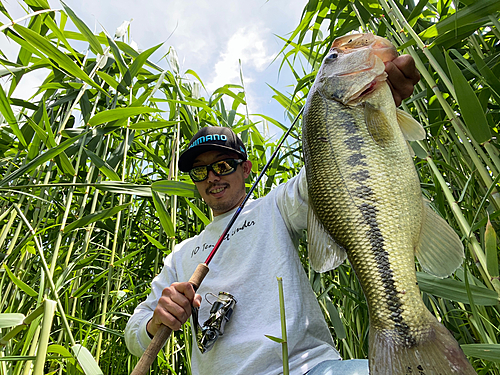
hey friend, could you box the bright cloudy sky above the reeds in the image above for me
[0,0,312,140]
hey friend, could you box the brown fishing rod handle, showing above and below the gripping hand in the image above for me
[130,263,209,375]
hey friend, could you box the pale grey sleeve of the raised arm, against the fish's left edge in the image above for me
[276,167,309,237]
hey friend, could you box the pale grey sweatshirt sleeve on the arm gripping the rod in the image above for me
[125,253,177,357]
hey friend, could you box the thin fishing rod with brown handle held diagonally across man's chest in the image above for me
[130,107,304,375]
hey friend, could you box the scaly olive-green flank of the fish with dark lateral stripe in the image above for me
[304,87,422,342]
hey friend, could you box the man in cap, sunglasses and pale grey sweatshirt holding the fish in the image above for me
[125,56,419,375]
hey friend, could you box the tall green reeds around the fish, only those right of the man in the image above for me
[276,0,500,374]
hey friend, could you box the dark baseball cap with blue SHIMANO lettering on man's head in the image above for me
[179,126,247,172]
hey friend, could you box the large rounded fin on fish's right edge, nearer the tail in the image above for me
[415,200,464,278]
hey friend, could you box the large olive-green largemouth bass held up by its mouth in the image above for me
[302,34,476,375]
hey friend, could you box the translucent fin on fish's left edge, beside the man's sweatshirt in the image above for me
[307,205,347,272]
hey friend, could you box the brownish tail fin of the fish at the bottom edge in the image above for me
[369,317,477,375]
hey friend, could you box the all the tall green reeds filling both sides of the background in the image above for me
[0,0,500,375]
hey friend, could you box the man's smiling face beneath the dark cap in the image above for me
[193,150,252,216]
